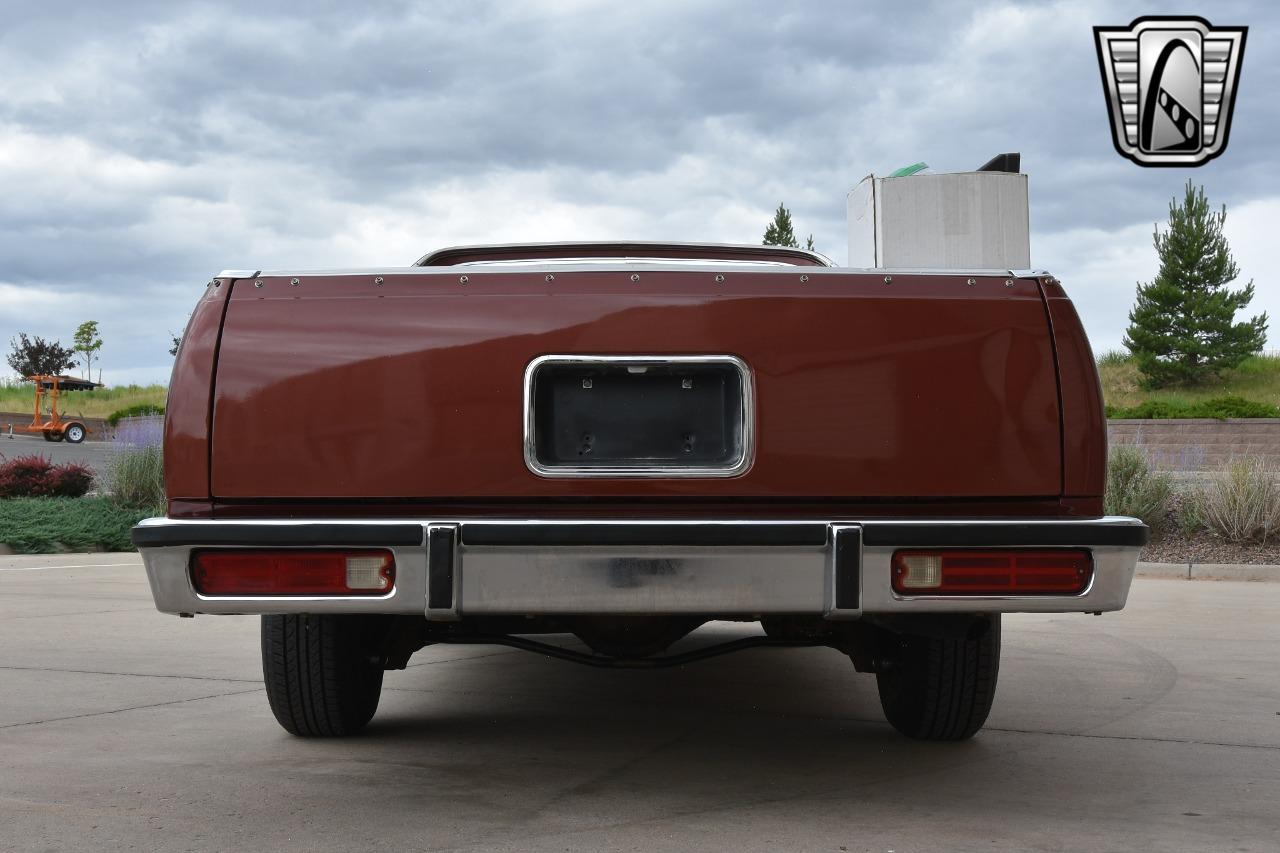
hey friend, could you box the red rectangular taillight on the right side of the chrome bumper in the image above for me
[893,549,1093,596]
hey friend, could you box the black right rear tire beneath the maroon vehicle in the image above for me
[876,615,1000,740]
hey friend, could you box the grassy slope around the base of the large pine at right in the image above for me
[1098,352,1280,416]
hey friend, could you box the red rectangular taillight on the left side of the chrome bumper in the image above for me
[191,549,396,596]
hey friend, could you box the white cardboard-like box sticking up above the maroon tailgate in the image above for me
[849,167,1032,270]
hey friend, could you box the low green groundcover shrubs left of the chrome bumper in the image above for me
[0,498,157,553]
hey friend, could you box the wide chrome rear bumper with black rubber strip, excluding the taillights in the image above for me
[133,516,1147,621]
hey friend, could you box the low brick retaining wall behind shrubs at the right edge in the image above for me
[1107,418,1280,471]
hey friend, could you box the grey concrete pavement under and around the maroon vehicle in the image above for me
[0,555,1280,853]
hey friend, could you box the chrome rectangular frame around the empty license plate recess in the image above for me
[524,355,755,479]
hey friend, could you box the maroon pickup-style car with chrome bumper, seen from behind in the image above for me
[133,243,1147,740]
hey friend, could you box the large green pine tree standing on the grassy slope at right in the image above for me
[1124,181,1267,388]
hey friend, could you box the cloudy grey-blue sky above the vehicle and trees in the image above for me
[0,0,1280,383]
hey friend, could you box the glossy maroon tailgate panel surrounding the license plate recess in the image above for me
[211,268,1061,500]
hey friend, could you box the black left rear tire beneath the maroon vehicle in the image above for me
[262,613,383,738]
